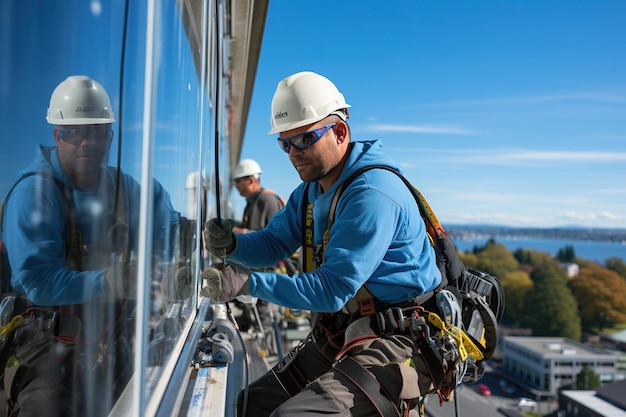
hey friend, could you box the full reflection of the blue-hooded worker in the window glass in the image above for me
[1,76,178,417]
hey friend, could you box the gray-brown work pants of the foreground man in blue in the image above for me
[238,324,430,417]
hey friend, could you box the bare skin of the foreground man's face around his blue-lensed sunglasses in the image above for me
[280,119,343,182]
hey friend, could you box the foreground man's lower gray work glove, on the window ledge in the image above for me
[200,264,250,302]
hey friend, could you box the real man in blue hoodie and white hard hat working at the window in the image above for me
[202,72,441,417]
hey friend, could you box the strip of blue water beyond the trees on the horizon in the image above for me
[452,236,626,264]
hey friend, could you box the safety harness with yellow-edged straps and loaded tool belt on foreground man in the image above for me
[302,165,504,417]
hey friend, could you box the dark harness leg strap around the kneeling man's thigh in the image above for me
[334,357,400,417]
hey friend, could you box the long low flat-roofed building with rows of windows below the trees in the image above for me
[501,336,617,398]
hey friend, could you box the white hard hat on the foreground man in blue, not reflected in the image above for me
[268,71,350,135]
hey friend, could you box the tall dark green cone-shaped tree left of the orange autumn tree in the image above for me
[525,262,582,341]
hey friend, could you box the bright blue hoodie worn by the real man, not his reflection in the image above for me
[228,141,441,312]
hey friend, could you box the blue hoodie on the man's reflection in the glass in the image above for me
[3,146,178,306]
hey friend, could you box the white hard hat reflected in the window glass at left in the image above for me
[46,75,115,125]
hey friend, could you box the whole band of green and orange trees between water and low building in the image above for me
[459,240,626,341]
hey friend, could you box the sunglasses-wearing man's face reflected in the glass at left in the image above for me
[54,124,113,182]
